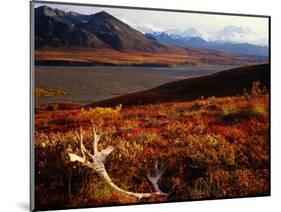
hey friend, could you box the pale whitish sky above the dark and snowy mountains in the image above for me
[35,3,268,43]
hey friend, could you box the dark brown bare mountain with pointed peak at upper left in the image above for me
[35,6,171,52]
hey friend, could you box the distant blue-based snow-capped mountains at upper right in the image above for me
[146,26,268,56]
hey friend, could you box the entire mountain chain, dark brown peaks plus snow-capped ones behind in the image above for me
[35,6,268,56]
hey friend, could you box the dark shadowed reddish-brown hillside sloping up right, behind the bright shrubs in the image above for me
[88,64,270,107]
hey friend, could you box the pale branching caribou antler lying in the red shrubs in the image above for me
[68,126,169,199]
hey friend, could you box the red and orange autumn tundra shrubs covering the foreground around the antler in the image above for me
[35,81,270,209]
